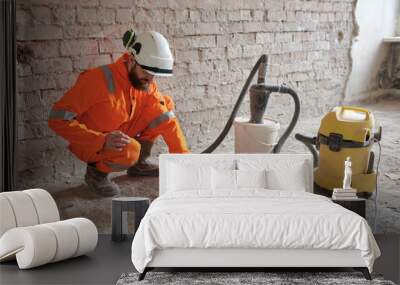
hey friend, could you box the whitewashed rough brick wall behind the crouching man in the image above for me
[17,0,354,188]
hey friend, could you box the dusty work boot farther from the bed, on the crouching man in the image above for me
[85,164,121,197]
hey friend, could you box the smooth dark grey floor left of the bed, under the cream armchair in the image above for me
[0,235,135,285]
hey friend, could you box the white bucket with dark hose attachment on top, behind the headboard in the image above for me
[234,117,280,153]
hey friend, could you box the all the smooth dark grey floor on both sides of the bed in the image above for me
[0,235,400,285]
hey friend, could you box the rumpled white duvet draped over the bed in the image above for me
[132,189,380,272]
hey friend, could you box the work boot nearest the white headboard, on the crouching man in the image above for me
[127,141,158,177]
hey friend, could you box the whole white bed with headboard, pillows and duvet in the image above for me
[132,154,380,279]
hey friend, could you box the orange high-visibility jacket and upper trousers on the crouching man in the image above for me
[49,51,189,161]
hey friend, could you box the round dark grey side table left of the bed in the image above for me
[111,197,150,241]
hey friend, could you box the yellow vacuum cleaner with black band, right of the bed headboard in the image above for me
[295,106,382,196]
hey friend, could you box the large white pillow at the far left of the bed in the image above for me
[167,163,211,191]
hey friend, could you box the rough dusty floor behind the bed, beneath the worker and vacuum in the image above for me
[45,97,400,233]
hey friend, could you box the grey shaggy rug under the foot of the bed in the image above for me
[116,272,395,285]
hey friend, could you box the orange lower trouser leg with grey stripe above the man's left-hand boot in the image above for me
[96,139,140,173]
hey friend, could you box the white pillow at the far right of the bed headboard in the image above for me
[267,163,308,192]
